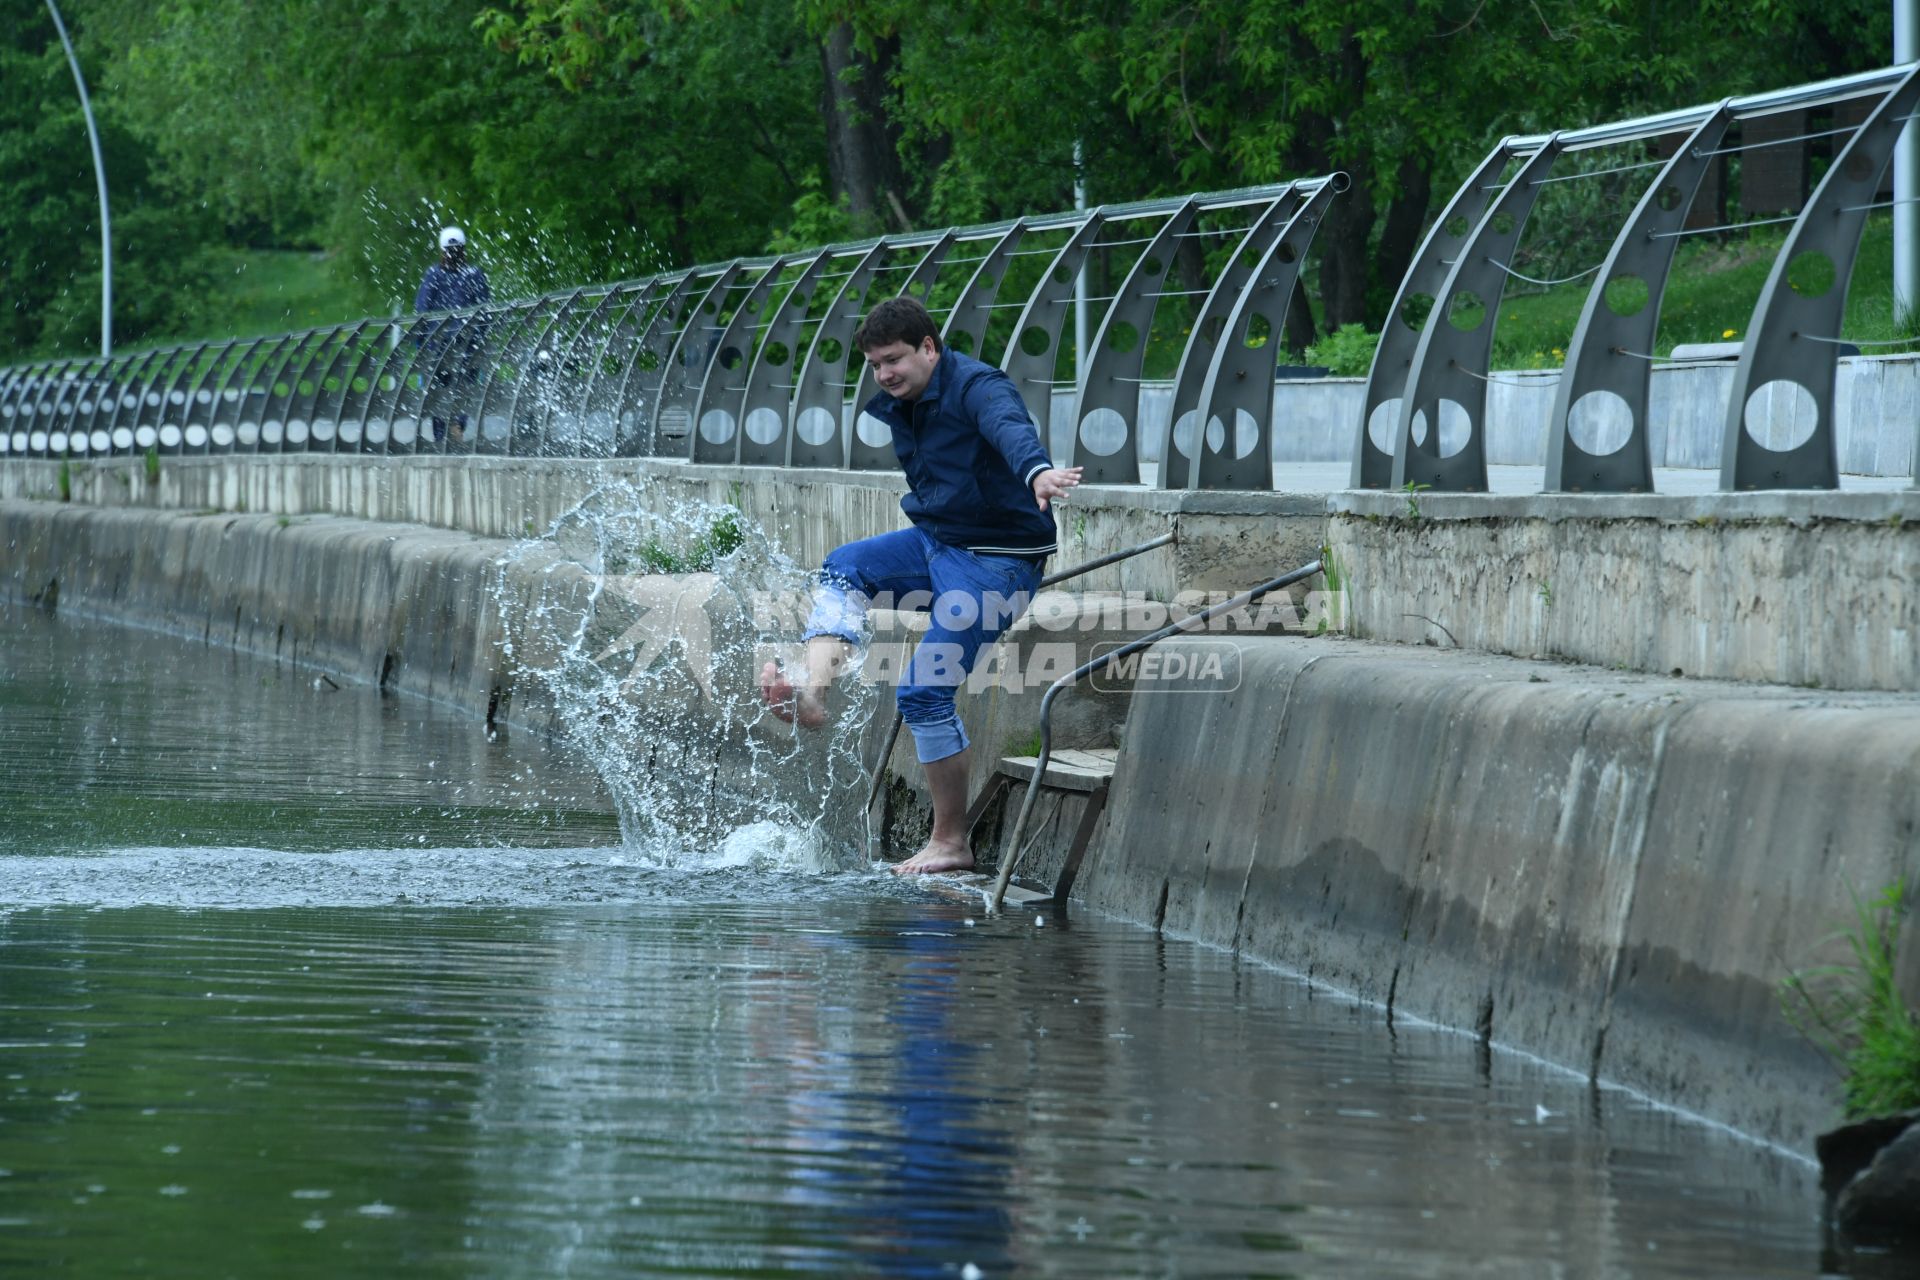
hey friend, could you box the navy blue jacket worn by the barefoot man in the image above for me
[866,347,1056,557]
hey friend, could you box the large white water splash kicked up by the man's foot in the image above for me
[495,480,876,871]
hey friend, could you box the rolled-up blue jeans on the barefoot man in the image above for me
[806,528,1041,764]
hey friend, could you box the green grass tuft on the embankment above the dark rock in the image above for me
[1780,879,1920,1119]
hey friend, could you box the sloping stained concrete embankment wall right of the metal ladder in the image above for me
[1081,639,1920,1150]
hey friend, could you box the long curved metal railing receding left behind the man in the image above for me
[0,173,1348,487]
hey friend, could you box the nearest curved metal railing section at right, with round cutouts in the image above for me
[1352,65,1920,493]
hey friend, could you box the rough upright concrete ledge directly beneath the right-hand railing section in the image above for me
[1327,491,1920,691]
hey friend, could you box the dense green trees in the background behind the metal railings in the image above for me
[0,0,1889,360]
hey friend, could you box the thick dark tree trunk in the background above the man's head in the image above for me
[820,23,912,230]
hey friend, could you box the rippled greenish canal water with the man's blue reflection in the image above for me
[0,608,1820,1280]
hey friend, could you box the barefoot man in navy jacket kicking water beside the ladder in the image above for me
[760,297,1081,875]
